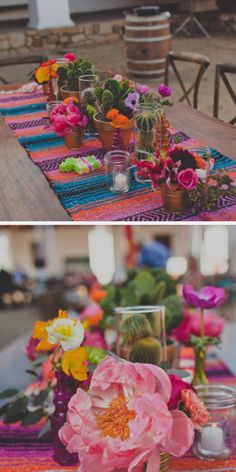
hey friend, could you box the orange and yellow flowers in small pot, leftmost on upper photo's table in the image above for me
[35,59,59,101]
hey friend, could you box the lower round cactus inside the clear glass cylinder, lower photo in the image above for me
[129,337,162,365]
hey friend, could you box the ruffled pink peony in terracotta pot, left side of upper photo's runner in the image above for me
[49,98,88,149]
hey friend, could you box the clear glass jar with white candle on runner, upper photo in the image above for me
[104,151,130,193]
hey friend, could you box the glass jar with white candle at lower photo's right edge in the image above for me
[193,385,236,459]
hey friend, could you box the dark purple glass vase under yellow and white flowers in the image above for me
[51,370,78,466]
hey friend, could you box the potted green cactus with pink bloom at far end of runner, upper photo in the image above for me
[58,53,93,100]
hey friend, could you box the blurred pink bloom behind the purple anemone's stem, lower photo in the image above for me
[171,310,225,344]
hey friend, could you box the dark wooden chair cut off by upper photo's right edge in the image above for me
[214,64,236,125]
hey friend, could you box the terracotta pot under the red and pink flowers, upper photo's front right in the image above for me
[160,184,191,213]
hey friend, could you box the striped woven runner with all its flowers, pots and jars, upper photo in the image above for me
[0,53,236,222]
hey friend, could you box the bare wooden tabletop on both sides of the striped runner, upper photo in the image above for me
[0,94,236,222]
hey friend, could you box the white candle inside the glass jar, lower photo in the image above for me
[201,424,224,454]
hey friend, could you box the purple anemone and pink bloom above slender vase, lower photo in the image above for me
[172,285,226,385]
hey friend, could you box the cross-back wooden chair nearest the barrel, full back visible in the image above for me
[165,52,210,109]
